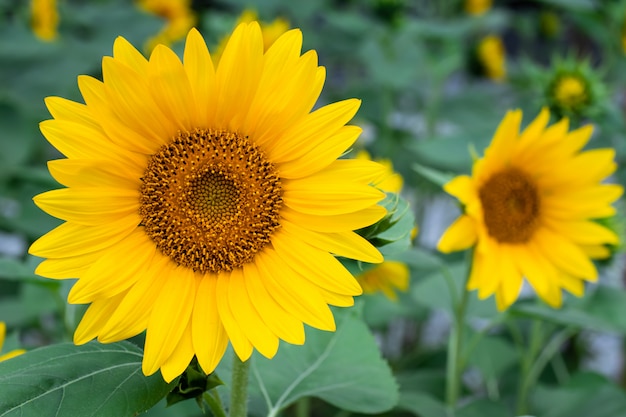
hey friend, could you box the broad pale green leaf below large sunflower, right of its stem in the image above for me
[218,311,398,416]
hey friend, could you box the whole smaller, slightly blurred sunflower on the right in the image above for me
[438,109,623,310]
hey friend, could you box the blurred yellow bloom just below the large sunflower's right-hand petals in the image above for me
[358,261,410,301]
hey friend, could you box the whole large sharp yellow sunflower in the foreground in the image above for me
[30,22,386,381]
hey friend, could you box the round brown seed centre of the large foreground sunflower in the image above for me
[139,129,282,273]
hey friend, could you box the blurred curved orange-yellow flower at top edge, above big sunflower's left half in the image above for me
[137,0,196,51]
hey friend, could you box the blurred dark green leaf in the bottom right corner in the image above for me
[532,373,626,417]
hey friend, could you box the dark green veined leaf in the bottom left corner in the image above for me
[0,342,171,417]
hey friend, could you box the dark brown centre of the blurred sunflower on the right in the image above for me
[479,168,540,243]
